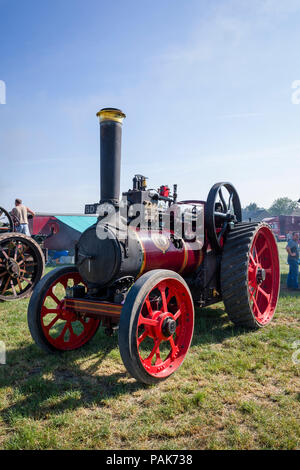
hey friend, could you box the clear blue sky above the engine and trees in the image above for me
[0,0,300,212]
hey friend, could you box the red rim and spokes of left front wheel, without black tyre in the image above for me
[41,272,100,351]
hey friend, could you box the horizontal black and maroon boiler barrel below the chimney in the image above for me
[76,223,203,287]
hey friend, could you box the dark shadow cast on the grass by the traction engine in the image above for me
[0,308,245,423]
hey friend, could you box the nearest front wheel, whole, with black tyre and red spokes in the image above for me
[119,269,194,384]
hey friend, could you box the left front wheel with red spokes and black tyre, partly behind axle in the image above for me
[28,266,100,352]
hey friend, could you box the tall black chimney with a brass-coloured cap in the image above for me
[97,108,126,205]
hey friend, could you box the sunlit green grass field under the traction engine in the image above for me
[0,243,300,450]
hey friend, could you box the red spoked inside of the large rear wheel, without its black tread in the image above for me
[248,227,280,325]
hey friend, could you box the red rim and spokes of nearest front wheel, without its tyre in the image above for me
[136,279,194,378]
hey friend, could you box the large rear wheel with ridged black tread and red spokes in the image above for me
[221,223,280,329]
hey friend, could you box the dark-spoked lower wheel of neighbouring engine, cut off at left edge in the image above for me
[0,233,45,300]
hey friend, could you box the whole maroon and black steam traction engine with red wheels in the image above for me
[28,108,279,384]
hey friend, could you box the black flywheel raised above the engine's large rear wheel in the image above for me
[205,183,242,253]
